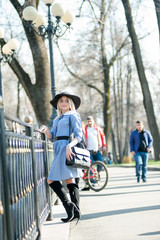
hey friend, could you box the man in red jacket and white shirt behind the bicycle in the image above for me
[82,116,107,191]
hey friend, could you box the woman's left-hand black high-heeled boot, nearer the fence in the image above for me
[49,181,76,222]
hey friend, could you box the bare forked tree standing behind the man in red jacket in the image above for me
[58,0,128,139]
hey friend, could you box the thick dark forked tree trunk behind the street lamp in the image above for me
[10,0,51,124]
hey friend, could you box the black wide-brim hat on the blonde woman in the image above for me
[50,92,81,109]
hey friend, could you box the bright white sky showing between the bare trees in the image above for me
[0,0,160,92]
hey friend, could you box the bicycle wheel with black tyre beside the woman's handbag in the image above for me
[86,161,108,192]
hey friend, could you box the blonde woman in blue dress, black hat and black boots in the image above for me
[41,92,82,222]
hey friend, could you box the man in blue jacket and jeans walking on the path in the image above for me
[130,121,153,183]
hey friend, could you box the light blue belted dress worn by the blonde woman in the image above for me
[48,111,82,181]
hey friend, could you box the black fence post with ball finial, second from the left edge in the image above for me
[26,126,41,240]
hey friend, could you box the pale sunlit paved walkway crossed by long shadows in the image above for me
[42,167,160,240]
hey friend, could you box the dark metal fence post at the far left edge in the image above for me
[0,106,13,240]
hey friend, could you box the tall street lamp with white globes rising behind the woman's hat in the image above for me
[23,0,73,127]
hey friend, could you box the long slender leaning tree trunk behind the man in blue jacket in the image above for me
[122,0,160,160]
